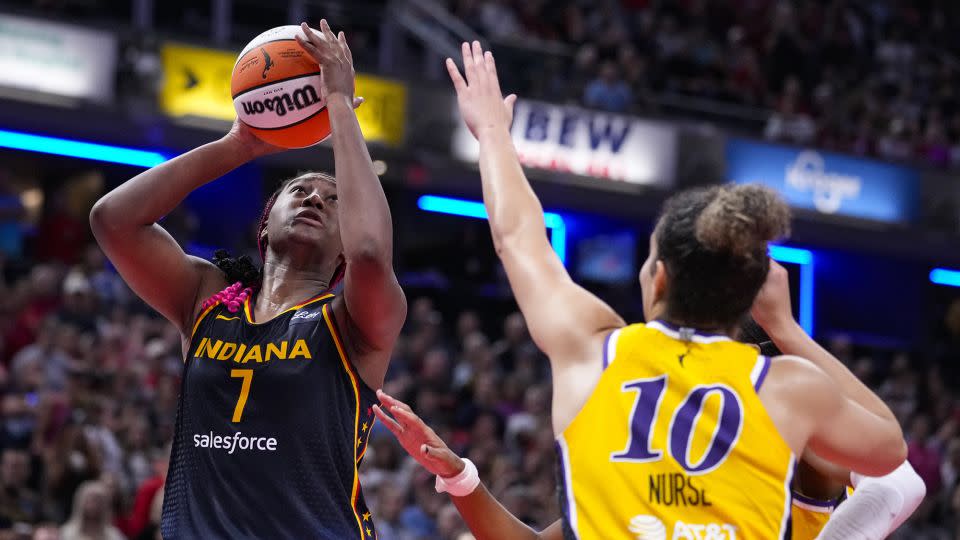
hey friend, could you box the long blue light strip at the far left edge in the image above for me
[0,129,167,167]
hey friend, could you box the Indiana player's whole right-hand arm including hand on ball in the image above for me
[298,20,407,388]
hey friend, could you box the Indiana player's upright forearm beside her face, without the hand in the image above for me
[327,94,393,264]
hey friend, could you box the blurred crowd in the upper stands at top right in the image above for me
[447,0,960,167]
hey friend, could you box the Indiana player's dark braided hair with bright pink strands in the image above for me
[200,172,346,312]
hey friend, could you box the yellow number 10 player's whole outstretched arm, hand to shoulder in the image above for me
[447,42,624,368]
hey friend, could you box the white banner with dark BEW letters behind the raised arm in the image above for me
[452,101,677,186]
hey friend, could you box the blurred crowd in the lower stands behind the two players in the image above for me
[0,230,960,540]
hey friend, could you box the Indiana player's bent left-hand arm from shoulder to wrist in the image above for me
[90,123,279,333]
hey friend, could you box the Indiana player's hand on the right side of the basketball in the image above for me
[296,19,356,103]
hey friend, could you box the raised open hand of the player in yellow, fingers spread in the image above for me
[447,41,517,139]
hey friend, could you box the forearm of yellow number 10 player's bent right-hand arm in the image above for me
[765,320,899,425]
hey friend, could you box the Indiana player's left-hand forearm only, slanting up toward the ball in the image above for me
[91,136,251,232]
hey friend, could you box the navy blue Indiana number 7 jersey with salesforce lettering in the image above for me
[161,294,376,540]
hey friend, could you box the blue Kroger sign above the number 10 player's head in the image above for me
[726,139,919,222]
